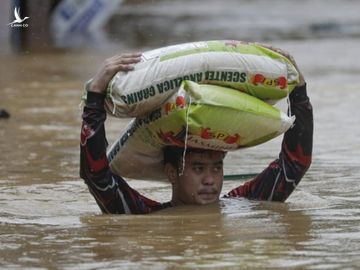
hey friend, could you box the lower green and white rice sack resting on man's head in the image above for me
[108,81,294,180]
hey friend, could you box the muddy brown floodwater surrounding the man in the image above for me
[0,1,360,269]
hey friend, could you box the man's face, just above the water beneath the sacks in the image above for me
[170,150,224,204]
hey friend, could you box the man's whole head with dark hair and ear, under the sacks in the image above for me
[164,146,225,205]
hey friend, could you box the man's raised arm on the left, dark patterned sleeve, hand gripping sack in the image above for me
[80,54,169,214]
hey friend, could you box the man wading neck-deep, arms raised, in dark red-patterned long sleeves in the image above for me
[80,47,313,214]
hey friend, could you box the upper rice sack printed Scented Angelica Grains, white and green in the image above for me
[106,40,299,117]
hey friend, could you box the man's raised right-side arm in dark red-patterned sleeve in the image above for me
[225,47,313,201]
